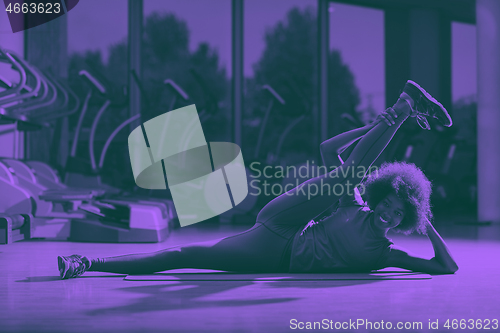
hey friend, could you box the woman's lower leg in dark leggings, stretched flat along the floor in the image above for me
[78,223,288,274]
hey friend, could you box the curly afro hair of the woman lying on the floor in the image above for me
[362,162,432,235]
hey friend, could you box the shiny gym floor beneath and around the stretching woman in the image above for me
[0,219,500,332]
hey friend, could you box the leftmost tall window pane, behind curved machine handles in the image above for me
[66,0,129,187]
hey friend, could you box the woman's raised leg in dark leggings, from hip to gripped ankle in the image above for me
[257,99,412,224]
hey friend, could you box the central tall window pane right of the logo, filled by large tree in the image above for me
[243,0,317,165]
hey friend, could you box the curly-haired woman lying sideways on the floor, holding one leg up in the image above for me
[58,81,458,279]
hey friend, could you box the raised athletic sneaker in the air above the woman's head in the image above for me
[403,80,453,129]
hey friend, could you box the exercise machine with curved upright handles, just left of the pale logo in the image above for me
[62,70,175,242]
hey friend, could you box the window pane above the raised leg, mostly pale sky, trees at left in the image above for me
[329,2,385,123]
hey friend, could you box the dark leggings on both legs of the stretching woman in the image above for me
[90,99,411,274]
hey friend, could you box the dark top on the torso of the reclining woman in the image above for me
[289,195,393,273]
